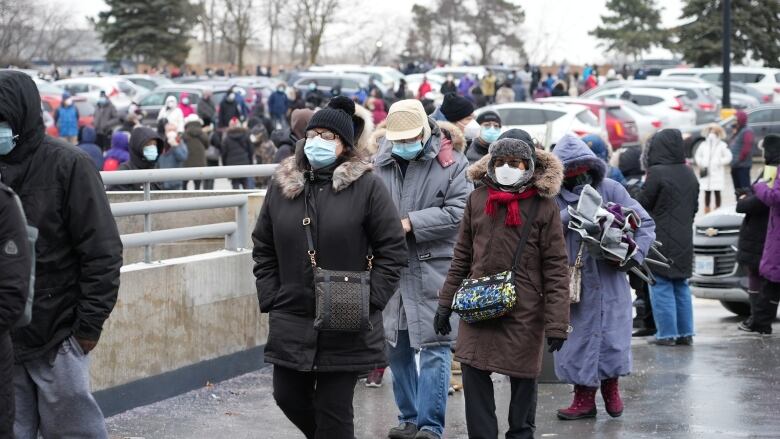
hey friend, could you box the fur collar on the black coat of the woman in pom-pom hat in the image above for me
[274,156,373,200]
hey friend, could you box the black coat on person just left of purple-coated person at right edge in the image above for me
[737,180,769,273]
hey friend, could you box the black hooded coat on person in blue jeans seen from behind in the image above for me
[637,129,699,279]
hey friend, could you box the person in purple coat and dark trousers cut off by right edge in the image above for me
[752,134,780,334]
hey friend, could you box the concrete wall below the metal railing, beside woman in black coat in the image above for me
[91,250,268,391]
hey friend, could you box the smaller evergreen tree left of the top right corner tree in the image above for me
[590,0,667,59]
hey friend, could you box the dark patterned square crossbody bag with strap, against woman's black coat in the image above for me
[303,183,374,332]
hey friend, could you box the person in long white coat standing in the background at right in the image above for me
[694,123,732,213]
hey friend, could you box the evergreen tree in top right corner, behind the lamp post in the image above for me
[676,0,780,67]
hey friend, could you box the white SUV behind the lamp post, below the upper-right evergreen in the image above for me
[661,66,780,102]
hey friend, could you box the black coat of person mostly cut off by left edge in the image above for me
[0,183,32,437]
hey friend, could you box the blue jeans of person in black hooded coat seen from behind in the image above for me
[650,276,693,340]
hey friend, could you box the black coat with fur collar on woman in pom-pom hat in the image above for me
[252,154,407,372]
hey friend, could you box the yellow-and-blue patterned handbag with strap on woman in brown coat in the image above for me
[452,198,539,323]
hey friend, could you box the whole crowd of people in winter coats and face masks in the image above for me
[0,59,780,439]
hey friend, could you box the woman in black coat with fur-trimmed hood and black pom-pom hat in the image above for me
[252,99,407,439]
